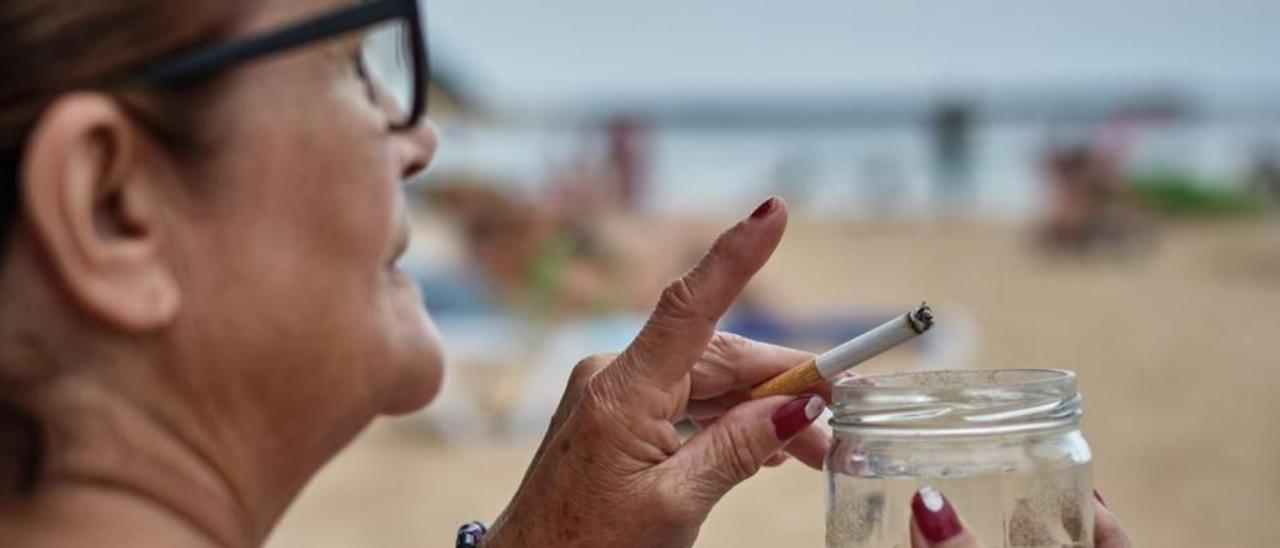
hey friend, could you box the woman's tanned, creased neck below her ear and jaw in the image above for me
[0,382,257,547]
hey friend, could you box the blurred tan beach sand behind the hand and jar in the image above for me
[269,222,1280,548]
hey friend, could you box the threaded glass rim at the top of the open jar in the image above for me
[831,369,1080,433]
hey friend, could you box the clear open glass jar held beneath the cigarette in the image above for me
[827,369,1093,548]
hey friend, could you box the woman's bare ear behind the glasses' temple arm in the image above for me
[19,92,180,330]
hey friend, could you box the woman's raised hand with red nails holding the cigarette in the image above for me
[484,198,828,548]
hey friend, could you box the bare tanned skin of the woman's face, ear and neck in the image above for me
[0,0,442,547]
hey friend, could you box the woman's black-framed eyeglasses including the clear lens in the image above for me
[131,0,430,129]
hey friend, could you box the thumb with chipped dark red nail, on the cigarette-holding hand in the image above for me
[663,394,827,511]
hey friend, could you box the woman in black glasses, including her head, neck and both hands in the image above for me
[0,0,1120,547]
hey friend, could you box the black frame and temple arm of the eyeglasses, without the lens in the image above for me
[129,0,431,129]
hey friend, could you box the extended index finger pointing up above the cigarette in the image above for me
[618,197,787,387]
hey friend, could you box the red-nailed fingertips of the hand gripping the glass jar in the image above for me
[911,488,1132,548]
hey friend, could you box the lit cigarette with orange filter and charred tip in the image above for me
[751,302,933,399]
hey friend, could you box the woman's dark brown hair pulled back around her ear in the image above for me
[0,0,243,499]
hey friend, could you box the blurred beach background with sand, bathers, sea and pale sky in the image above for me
[264,0,1280,548]
